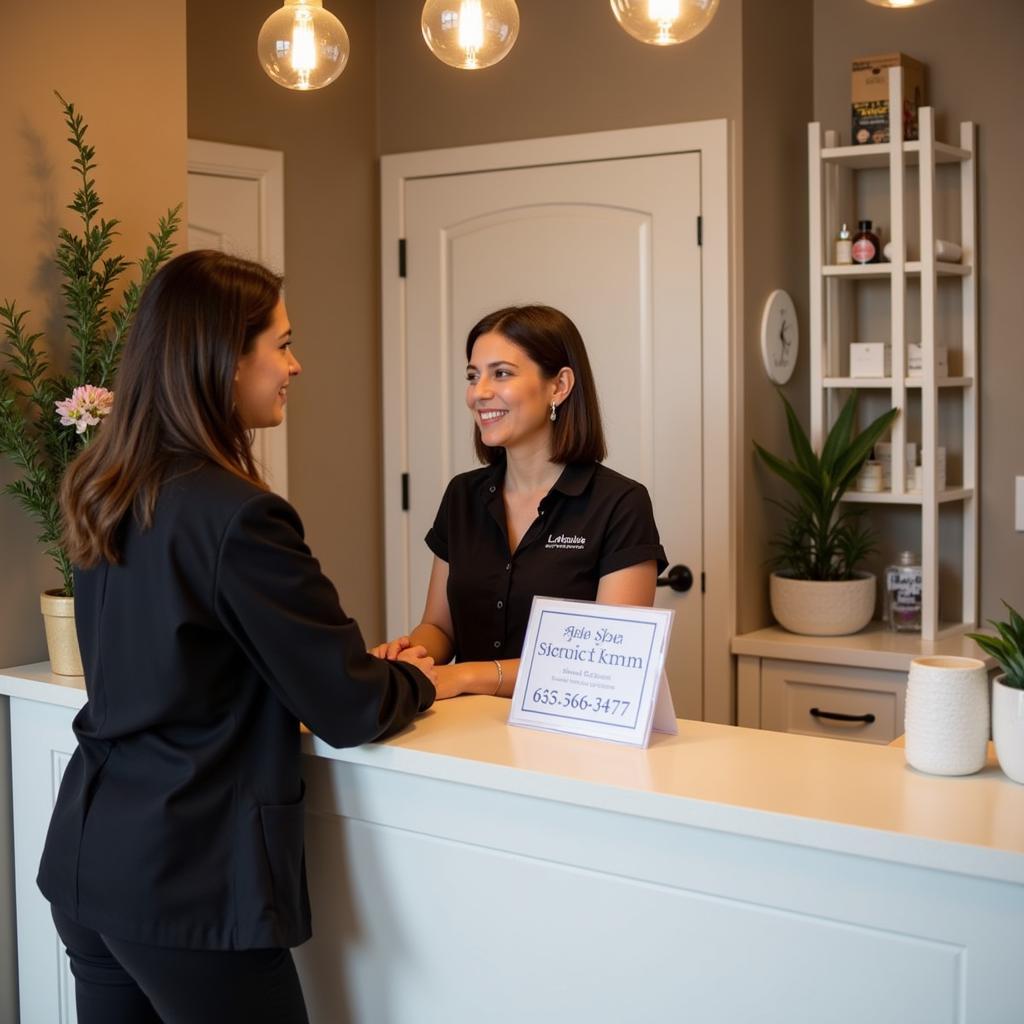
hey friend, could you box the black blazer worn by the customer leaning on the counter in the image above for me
[38,464,434,949]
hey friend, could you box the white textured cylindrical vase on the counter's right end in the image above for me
[904,656,989,775]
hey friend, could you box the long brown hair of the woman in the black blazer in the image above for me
[60,250,282,567]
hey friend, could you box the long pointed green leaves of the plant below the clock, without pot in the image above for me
[754,391,899,580]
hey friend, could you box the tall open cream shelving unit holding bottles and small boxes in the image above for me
[808,68,978,641]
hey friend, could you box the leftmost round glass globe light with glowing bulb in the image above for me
[256,0,349,92]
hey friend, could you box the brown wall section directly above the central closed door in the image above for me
[377,0,741,154]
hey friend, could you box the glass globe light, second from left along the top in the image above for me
[420,0,519,71]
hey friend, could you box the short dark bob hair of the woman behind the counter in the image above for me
[466,306,608,466]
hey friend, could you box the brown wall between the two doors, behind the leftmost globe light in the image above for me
[187,0,383,642]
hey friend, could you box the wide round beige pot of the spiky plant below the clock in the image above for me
[769,572,876,637]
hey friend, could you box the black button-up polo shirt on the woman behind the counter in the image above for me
[426,462,668,662]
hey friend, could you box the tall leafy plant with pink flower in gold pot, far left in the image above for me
[0,93,181,675]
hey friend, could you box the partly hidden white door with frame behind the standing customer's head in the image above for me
[187,139,288,498]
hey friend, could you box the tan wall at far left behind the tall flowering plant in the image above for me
[0,0,185,1020]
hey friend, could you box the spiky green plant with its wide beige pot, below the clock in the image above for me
[754,391,899,636]
